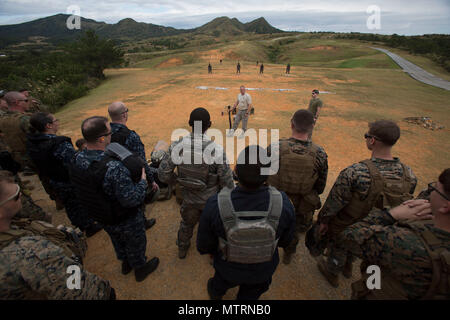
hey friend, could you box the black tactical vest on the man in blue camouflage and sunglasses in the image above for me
[70,143,143,225]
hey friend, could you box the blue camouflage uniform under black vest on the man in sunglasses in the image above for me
[74,150,147,269]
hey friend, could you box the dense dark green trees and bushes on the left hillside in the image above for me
[0,30,124,112]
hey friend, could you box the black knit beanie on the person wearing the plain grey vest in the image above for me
[236,145,270,189]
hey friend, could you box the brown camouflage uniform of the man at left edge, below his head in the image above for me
[0,111,31,169]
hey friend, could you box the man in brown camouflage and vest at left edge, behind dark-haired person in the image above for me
[0,91,31,170]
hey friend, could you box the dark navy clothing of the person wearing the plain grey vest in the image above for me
[197,186,295,300]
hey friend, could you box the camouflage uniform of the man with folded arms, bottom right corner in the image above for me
[343,209,450,300]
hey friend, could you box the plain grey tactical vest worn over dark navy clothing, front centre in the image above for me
[218,187,283,264]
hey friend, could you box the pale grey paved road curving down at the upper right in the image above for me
[371,47,450,90]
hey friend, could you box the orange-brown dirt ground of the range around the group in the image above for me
[27,52,450,299]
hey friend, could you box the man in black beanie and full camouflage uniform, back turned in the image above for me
[158,108,234,259]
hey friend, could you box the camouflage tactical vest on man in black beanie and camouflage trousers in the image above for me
[177,141,217,191]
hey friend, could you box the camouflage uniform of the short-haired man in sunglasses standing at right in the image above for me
[318,158,417,275]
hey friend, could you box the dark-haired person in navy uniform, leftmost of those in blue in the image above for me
[27,112,102,237]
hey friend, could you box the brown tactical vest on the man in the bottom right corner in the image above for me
[352,221,450,300]
